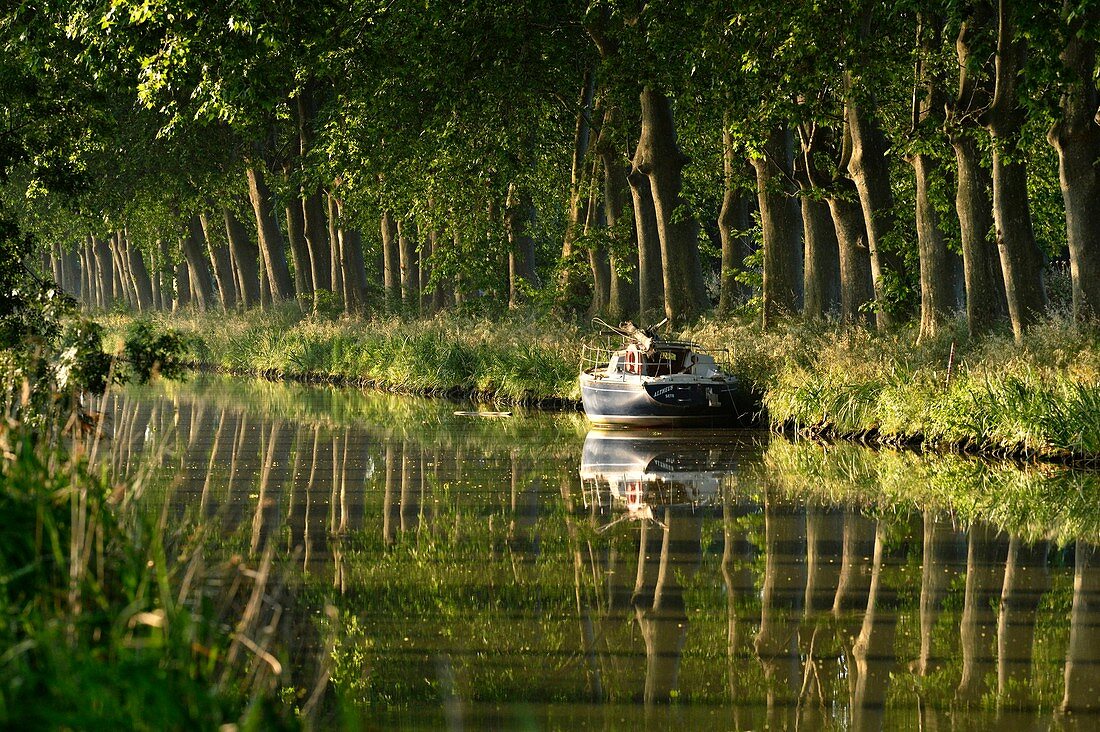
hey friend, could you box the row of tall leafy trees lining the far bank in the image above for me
[0,0,1100,337]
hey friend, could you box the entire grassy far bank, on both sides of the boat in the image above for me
[105,308,1100,460]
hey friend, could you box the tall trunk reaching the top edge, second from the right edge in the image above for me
[987,0,1046,342]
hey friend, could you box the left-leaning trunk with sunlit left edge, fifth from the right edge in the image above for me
[845,94,904,329]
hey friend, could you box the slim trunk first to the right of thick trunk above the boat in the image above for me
[718,125,756,315]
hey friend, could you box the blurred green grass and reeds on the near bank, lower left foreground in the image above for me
[0,376,296,730]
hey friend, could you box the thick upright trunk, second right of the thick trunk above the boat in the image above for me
[751,127,802,328]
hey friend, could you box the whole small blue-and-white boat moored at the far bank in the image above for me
[580,319,754,427]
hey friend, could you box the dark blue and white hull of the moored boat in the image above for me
[581,379,752,427]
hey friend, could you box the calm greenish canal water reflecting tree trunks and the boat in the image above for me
[109,378,1100,730]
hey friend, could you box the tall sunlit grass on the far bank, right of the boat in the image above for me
[688,316,1100,458]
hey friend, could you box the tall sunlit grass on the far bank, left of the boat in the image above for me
[106,308,580,404]
